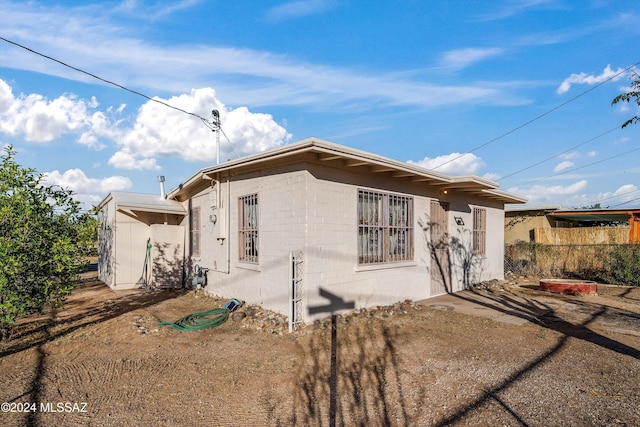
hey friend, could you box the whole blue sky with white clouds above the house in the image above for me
[0,0,640,208]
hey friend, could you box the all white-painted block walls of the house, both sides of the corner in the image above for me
[192,165,504,322]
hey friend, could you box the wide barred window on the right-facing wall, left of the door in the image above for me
[358,190,413,264]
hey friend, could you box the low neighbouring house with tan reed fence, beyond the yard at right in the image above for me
[505,204,640,245]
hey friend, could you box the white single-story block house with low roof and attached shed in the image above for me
[99,138,526,325]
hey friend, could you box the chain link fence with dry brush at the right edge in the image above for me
[504,242,640,286]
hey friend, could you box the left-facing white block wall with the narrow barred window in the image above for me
[194,169,307,314]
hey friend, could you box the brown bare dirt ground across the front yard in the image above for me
[0,272,640,426]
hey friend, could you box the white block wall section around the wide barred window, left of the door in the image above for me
[307,173,429,320]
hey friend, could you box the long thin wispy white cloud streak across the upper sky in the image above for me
[2,2,524,110]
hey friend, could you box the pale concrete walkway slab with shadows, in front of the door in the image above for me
[418,289,554,325]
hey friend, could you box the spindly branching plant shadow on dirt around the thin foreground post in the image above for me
[269,321,426,426]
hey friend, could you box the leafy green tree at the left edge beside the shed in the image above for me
[0,146,90,338]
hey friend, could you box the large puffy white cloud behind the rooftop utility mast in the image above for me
[109,88,291,169]
